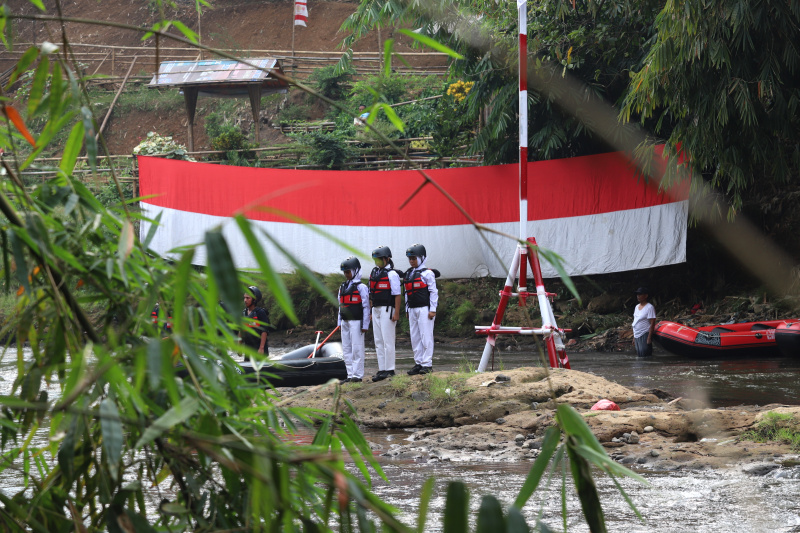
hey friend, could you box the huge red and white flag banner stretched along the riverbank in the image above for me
[139,148,688,278]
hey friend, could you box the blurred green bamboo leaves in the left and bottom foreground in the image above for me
[0,0,638,533]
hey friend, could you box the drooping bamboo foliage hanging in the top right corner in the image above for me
[622,0,800,215]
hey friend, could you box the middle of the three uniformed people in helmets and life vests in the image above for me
[369,246,400,381]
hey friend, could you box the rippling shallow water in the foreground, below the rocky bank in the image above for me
[366,454,800,533]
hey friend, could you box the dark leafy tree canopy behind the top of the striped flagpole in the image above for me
[342,0,659,164]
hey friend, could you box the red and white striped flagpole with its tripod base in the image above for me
[475,0,570,372]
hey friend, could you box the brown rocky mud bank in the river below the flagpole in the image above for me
[280,368,800,475]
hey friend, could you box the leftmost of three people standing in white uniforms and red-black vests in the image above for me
[337,256,369,383]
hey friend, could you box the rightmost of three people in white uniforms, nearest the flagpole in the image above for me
[403,244,439,376]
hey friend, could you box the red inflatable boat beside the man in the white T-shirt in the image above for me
[653,320,800,359]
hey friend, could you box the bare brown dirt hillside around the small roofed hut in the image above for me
[0,0,441,154]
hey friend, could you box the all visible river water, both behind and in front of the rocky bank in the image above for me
[0,349,800,533]
